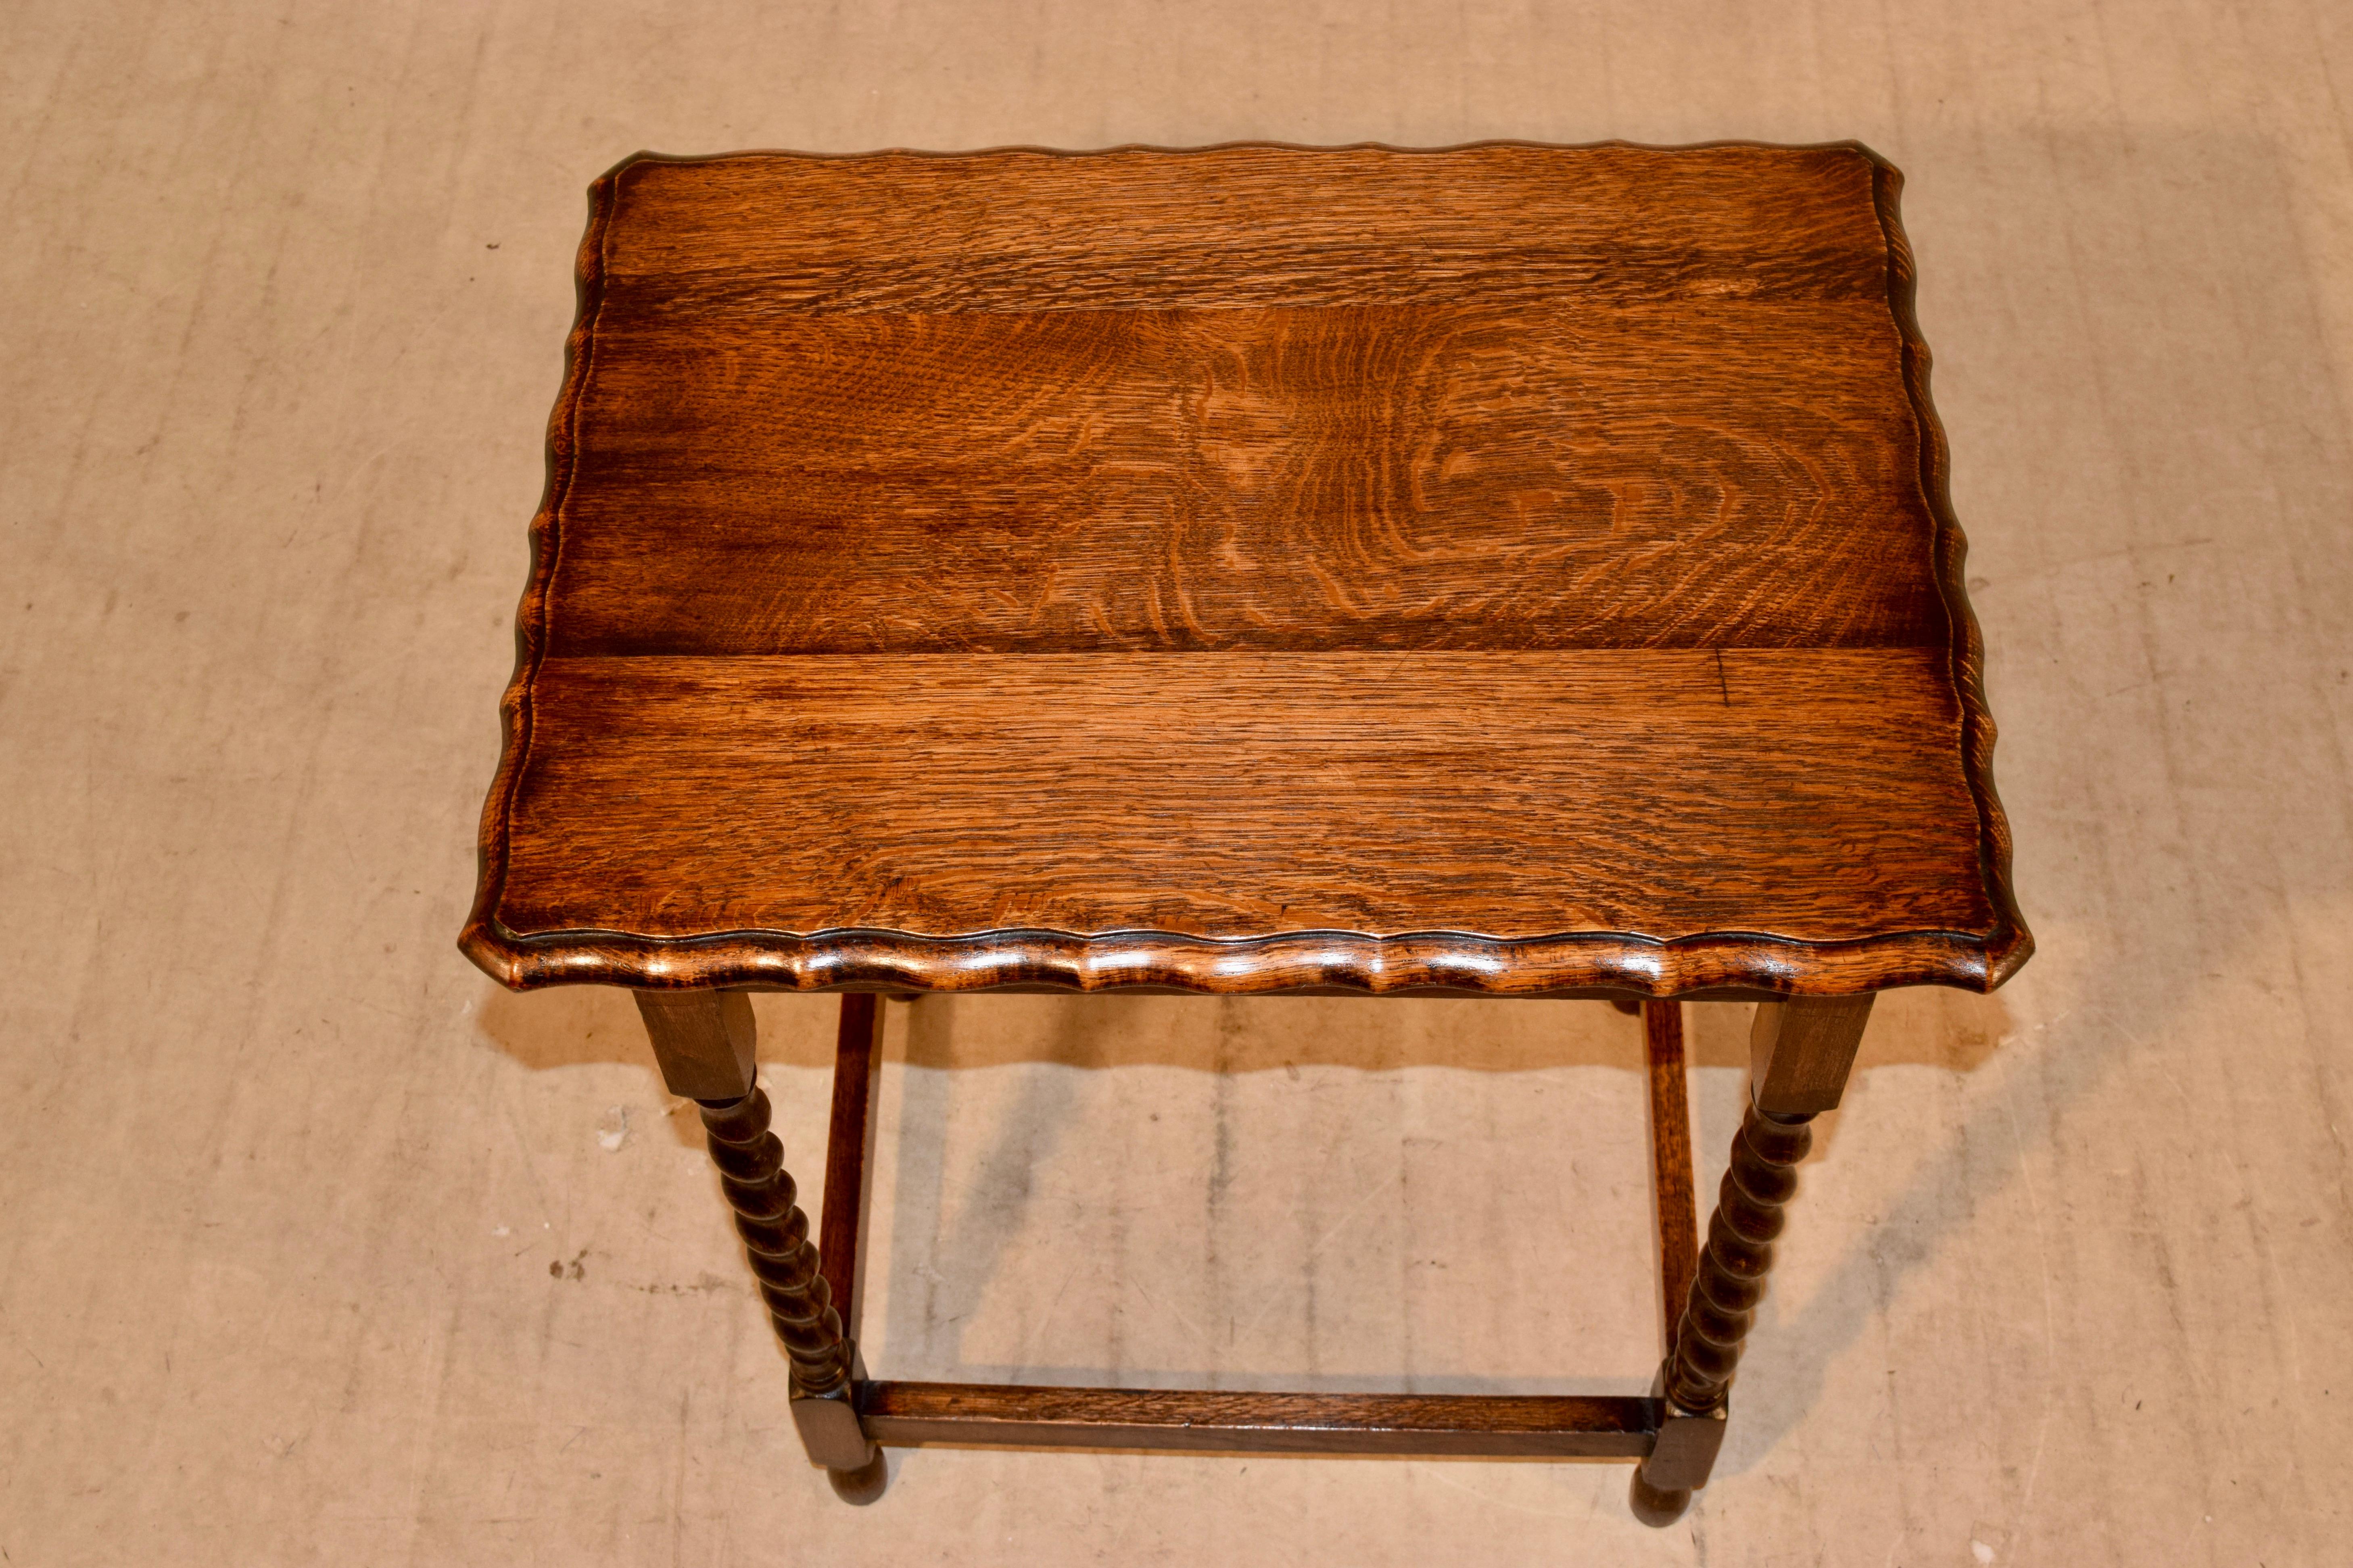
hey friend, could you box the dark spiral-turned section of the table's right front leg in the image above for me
[1666,1105,1814,1415]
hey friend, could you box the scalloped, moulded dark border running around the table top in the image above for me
[459,150,2033,997]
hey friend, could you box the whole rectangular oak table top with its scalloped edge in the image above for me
[461,144,2031,995]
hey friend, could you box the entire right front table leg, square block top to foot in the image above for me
[1633,997,1871,1523]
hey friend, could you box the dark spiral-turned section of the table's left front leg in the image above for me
[704,1086,850,1399]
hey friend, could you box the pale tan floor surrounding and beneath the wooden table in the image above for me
[0,0,2353,1568]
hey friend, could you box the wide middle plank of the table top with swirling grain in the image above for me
[548,298,1946,656]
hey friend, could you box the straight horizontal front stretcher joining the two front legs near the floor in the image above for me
[859,1382,1659,1460]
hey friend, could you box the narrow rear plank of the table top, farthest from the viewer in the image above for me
[598,144,1885,315]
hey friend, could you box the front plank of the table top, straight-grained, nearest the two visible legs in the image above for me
[501,649,1991,949]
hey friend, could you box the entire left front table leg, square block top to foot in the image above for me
[638,992,885,1502]
